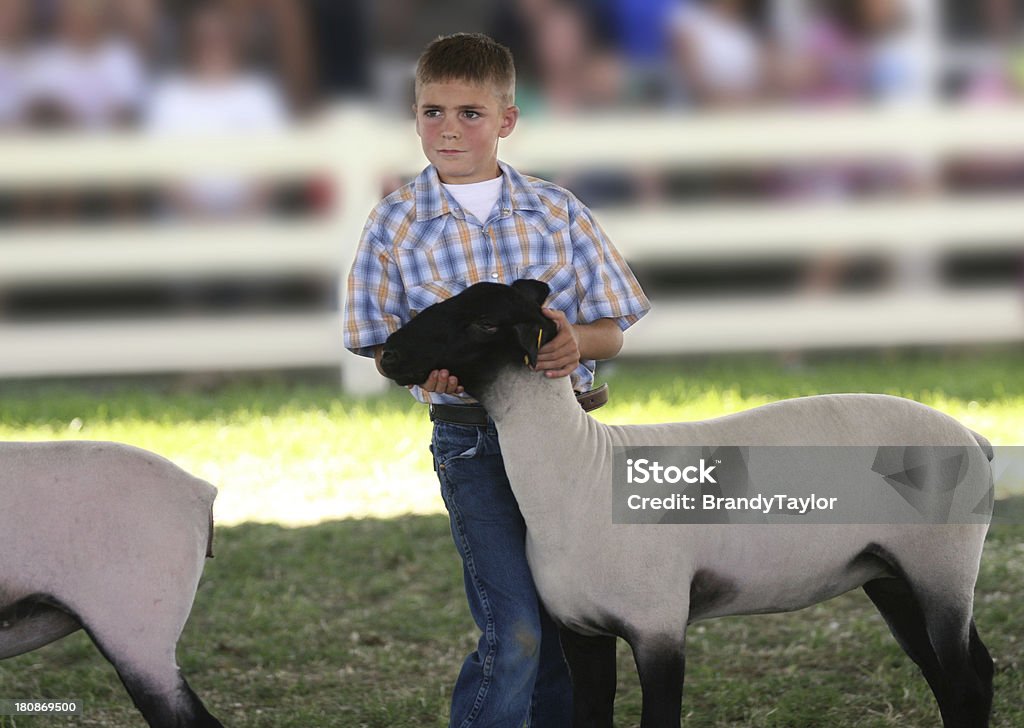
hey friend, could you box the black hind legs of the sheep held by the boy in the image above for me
[864,579,992,728]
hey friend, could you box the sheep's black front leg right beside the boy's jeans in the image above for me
[558,628,615,728]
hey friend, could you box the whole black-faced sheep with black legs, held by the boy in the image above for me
[381,281,993,728]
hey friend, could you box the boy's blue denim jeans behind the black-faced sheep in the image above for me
[430,422,572,728]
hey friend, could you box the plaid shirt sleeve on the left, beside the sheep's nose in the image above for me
[342,216,409,356]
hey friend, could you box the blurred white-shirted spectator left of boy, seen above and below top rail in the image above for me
[147,4,288,218]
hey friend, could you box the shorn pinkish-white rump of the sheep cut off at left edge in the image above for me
[0,441,217,634]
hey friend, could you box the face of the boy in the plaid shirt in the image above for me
[413,80,519,184]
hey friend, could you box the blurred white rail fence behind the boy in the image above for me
[0,103,1024,391]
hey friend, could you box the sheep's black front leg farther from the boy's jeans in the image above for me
[632,639,686,728]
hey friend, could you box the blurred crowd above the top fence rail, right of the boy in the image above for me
[489,0,1024,111]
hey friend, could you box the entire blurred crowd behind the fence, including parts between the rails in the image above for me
[0,0,1024,329]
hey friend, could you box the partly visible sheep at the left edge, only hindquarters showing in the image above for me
[0,441,221,728]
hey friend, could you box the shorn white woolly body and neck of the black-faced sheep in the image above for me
[480,368,988,639]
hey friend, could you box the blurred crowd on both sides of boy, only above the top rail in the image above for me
[0,0,1024,130]
